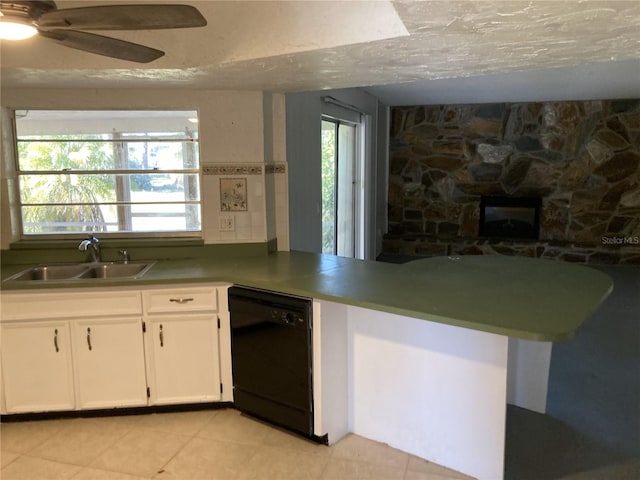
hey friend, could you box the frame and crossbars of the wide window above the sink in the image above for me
[10,108,204,242]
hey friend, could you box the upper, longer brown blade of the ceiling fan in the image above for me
[38,4,207,30]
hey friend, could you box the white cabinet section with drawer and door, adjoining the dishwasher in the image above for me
[142,287,230,404]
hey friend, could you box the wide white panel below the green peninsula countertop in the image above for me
[349,307,507,480]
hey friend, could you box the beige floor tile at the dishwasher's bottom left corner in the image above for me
[196,409,272,445]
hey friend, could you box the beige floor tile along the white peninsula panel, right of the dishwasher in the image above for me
[331,434,409,472]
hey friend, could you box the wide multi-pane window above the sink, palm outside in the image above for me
[15,110,201,236]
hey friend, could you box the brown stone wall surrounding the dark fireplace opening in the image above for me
[384,100,640,263]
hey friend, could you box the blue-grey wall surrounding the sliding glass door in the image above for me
[286,89,386,259]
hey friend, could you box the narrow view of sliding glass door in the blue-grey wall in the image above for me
[322,116,363,258]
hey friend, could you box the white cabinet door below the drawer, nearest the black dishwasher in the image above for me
[145,313,220,404]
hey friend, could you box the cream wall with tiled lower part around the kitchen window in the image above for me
[0,89,288,248]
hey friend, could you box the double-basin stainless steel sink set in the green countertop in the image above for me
[5,261,155,282]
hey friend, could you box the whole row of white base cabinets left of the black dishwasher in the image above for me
[0,285,233,414]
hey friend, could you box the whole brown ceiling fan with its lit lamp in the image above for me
[0,0,207,63]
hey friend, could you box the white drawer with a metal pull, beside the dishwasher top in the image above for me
[142,287,218,314]
